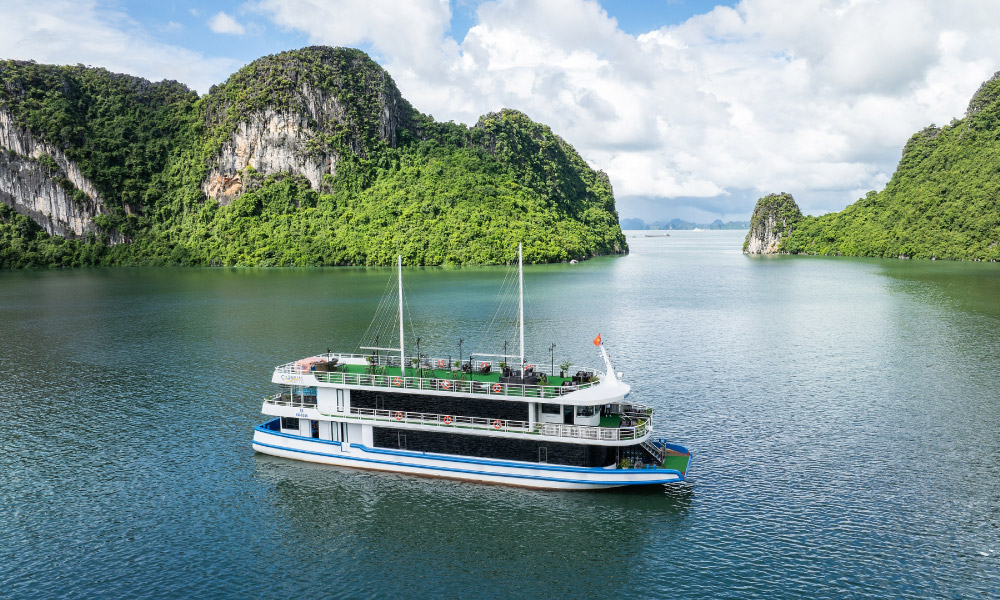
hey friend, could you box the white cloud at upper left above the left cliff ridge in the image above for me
[0,0,240,92]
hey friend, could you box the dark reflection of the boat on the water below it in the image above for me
[254,453,693,596]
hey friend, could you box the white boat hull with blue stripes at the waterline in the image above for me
[253,427,684,490]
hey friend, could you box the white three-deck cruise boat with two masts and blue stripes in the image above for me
[253,247,691,489]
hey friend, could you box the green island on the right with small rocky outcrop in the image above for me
[743,73,1000,261]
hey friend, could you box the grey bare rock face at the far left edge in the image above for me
[0,111,107,237]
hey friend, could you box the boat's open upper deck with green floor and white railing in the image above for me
[272,353,629,405]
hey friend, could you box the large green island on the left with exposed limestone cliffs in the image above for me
[0,46,628,268]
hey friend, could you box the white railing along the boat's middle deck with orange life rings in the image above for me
[337,407,652,441]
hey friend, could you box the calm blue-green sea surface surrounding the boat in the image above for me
[0,232,1000,599]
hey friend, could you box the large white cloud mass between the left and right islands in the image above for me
[402,0,1000,220]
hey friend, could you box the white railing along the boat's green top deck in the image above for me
[310,371,597,400]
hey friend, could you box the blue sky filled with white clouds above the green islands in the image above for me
[0,0,1000,222]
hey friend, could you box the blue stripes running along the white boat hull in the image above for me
[253,427,684,486]
